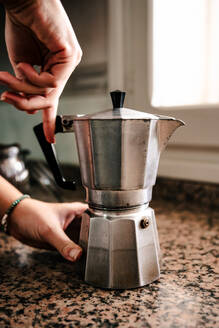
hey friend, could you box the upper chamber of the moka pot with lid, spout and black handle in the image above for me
[34,91,184,208]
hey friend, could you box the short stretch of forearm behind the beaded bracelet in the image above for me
[0,176,22,220]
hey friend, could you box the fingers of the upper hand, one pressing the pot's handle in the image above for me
[0,45,82,143]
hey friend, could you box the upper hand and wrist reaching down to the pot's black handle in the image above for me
[0,0,82,143]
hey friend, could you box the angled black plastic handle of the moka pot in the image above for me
[33,116,76,190]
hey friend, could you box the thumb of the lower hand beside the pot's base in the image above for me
[45,226,82,262]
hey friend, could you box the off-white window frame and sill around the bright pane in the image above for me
[108,0,219,183]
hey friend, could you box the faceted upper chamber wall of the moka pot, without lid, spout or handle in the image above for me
[74,119,160,207]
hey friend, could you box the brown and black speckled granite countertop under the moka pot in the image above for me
[0,191,219,328]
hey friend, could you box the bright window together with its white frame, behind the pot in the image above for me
[109,0,219,183]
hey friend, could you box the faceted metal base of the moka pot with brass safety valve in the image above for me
[79,204,160,289]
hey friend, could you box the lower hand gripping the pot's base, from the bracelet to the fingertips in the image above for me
[8,198,87,262]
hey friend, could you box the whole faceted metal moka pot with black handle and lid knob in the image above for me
[34,91,184,289]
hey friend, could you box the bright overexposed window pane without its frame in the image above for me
[152,0,219,107]
